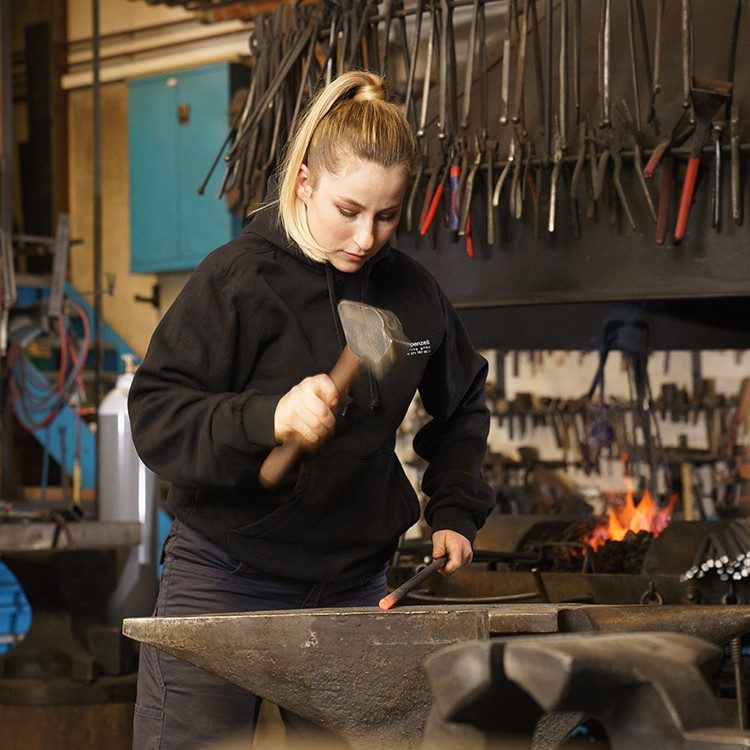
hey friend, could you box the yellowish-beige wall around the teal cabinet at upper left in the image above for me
[63,0,246,356]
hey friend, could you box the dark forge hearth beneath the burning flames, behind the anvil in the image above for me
[388,514,750,604]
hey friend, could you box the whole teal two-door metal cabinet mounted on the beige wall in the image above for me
[128,63,247,273]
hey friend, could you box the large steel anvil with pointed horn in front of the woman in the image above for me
[123,604,750,748]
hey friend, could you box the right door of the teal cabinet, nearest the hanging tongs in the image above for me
[178,63,233,266]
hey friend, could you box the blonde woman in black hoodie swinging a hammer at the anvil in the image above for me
[130,67,494,750]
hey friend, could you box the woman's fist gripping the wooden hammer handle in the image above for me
[273,375,339,450]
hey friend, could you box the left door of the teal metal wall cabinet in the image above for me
[128,75,179,272]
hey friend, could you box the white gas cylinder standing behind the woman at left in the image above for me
[98,354,158,627]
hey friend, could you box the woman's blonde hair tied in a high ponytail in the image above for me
[279,70,416,262]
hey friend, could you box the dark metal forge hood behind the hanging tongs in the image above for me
[400,0,750,307]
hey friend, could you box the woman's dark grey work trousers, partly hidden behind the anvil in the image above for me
[133,521,387,750]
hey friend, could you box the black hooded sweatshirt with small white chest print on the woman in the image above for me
[129,208,494,581]
